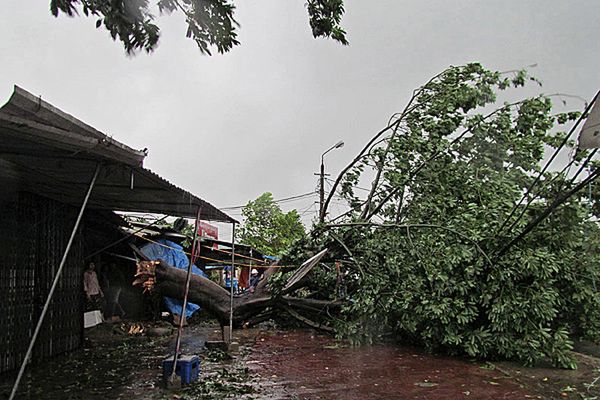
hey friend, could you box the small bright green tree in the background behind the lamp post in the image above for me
[236,192,305,255]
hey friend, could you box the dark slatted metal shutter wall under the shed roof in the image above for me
[0,192,83,373]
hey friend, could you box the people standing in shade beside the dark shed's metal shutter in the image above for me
[83,262,125,320]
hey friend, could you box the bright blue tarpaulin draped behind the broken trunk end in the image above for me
[140,239,206,318]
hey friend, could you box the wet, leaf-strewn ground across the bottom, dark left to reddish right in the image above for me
[0,321,600,400]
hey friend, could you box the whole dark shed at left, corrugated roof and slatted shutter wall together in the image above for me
[0,87,235,373]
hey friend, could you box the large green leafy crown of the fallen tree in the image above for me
[288,64,600,367]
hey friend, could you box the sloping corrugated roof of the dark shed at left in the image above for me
[0,86,236,222]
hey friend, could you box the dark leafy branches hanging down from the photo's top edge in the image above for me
[50,0,348,55]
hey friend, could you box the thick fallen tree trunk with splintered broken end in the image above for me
[134,252,343,329]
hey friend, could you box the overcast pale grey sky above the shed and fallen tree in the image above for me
[0,0,600,236]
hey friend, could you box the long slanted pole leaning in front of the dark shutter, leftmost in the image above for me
[8,164,100,400]
